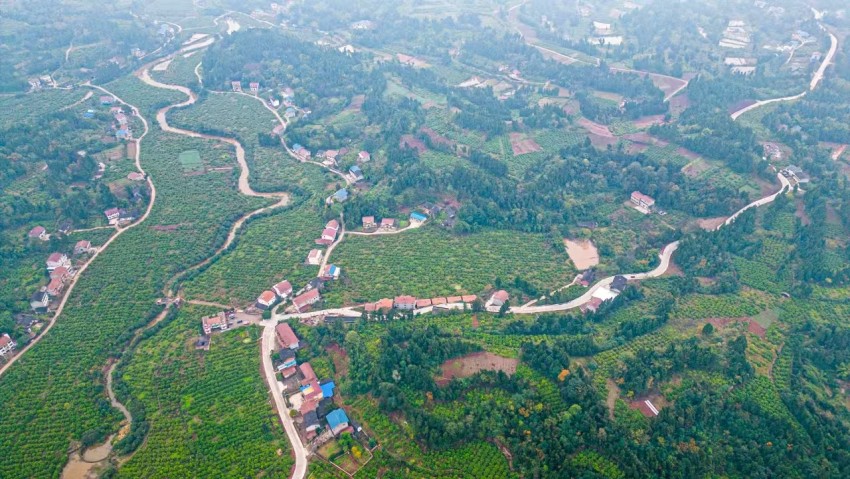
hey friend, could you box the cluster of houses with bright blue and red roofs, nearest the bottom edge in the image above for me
[275,323,354,441]
